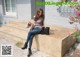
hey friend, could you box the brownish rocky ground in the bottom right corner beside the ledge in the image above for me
[64,43,80,57]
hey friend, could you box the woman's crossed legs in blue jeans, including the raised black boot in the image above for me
[22,28,42,49]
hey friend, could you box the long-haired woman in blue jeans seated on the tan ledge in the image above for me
[22,9,44,56]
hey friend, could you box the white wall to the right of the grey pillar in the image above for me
[45,0,80,28]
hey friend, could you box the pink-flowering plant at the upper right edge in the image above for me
[69,5,80,24]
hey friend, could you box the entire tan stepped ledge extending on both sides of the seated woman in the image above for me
[0,21,76,57]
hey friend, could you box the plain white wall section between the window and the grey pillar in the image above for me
[16,0,31,20]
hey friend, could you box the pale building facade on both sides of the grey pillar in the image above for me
[0,0,80,27]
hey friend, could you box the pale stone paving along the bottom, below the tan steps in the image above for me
[0,37,51,57]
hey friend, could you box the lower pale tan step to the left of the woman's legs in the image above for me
[0,26,28,39]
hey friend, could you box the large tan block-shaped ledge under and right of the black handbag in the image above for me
[33,26,76,57]
